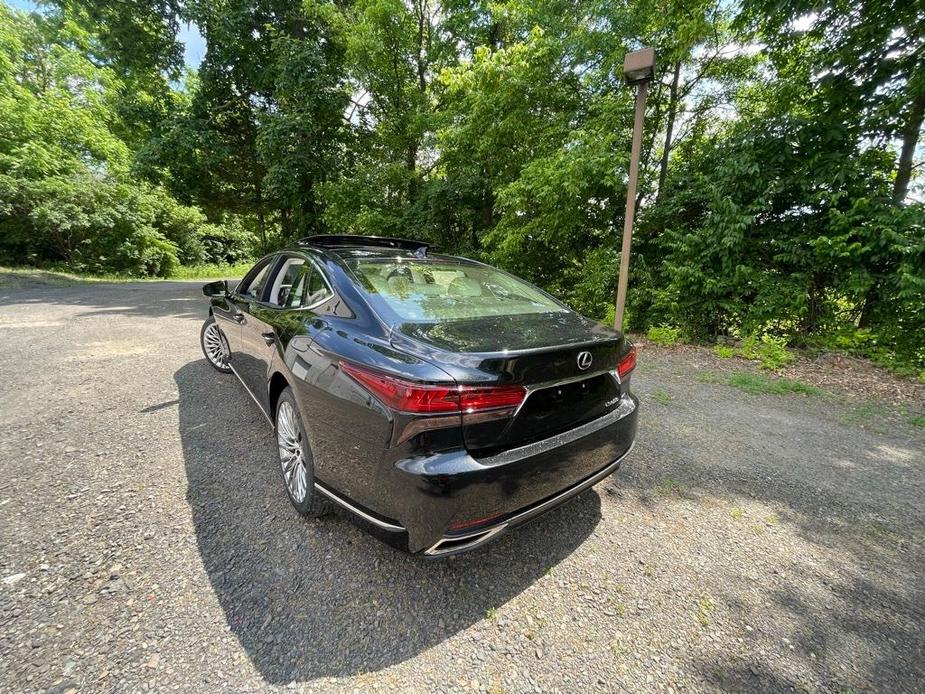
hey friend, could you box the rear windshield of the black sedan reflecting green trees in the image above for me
[348,258,568,322]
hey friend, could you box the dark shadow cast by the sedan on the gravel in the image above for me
[175,360,601,684]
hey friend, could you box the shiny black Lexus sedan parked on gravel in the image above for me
[201,236,638,556]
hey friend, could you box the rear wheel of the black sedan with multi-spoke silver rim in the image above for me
[276,386,330,518]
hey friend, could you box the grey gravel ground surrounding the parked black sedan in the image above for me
[0,282,925,692]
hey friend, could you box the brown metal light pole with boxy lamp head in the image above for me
[613,48,655,330]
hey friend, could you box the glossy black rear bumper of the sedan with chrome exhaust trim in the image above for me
[386,393,638,557]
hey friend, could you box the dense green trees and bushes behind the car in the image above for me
[0,0,925,371]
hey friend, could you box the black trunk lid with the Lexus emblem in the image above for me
[398,311,624,457]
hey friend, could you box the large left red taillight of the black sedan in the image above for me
[341,362,526,414]
